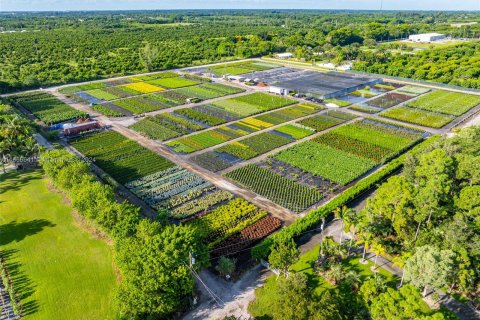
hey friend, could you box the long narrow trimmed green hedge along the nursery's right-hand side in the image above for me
[251,136,440,259]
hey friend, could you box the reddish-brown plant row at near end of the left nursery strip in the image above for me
[211,215,282,257]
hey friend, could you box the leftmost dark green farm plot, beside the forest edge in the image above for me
[11,92,87,125]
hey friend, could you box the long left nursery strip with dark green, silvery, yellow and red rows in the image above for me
[66,131,281,254]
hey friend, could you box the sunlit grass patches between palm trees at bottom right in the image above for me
[248,245,398,319]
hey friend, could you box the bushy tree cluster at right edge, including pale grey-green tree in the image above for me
[357,127,480,294]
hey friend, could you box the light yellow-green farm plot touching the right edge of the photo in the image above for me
[407,90,480,116]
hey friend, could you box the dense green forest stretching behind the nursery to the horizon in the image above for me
[0,10,480,92]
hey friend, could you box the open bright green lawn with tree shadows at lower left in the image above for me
[0,172,117,320]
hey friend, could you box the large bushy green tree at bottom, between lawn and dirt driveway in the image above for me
[116,220,206,318]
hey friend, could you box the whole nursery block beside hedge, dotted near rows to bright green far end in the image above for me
[225,119,422,212]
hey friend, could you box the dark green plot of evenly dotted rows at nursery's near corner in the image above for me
[225,164,323,212]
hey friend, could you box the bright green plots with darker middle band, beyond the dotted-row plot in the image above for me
[274,120,421,185]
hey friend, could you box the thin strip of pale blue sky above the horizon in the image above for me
[0,0,480,11]
